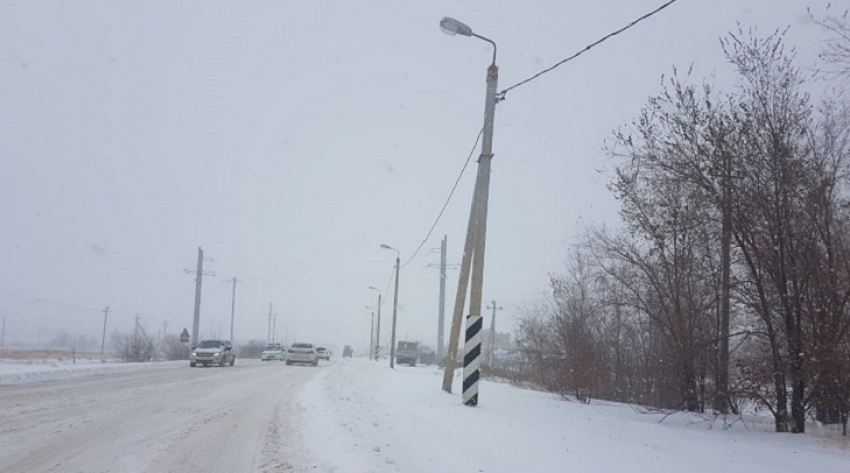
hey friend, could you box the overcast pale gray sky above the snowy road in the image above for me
[0,0,836,349]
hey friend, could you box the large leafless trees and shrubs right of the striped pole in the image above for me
[510,23,850,432]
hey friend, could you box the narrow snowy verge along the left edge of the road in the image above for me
[0,359,186,386]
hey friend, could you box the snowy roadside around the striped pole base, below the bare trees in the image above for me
[293,359,850,473]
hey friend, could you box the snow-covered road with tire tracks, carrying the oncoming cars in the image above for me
[0,360,318,472]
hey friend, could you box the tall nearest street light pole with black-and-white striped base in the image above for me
[440,17,499,406]
